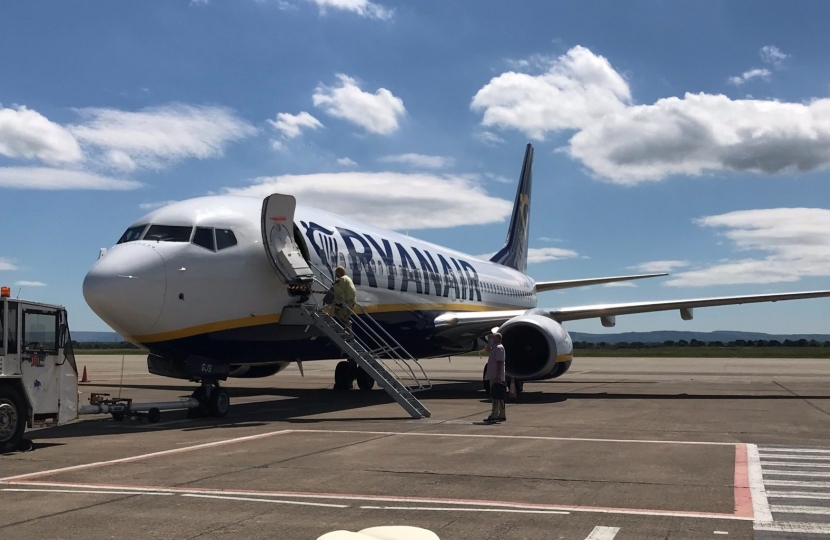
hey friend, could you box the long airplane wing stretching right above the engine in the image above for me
[434,291,830,335]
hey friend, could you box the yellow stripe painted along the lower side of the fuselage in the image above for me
[133,302,502,343]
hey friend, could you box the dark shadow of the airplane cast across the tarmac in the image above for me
[22,381,830,442]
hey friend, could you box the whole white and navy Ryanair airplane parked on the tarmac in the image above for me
[83,144,830,417]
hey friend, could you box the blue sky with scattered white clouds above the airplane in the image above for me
[0,0,830,333]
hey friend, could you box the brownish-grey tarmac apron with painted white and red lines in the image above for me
[0,356,830,540]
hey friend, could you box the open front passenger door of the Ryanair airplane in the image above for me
[262,193,314,285]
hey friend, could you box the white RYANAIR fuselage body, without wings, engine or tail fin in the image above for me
[84,196,536,362]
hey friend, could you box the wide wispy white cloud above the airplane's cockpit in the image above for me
[69,104,257,169]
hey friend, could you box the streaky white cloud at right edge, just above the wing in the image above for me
[666,208,830,287]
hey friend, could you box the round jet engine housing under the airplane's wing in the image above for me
[499,314,573,381]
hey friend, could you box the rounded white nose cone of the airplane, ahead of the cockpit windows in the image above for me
[84,243,167,336]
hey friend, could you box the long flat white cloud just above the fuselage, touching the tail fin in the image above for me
[225,172,513,230]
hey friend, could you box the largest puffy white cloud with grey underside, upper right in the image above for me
[471,46,830,185]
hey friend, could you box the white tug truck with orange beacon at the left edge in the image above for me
[0,287,78,453]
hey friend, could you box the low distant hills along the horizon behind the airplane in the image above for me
[72,330,830,343]
